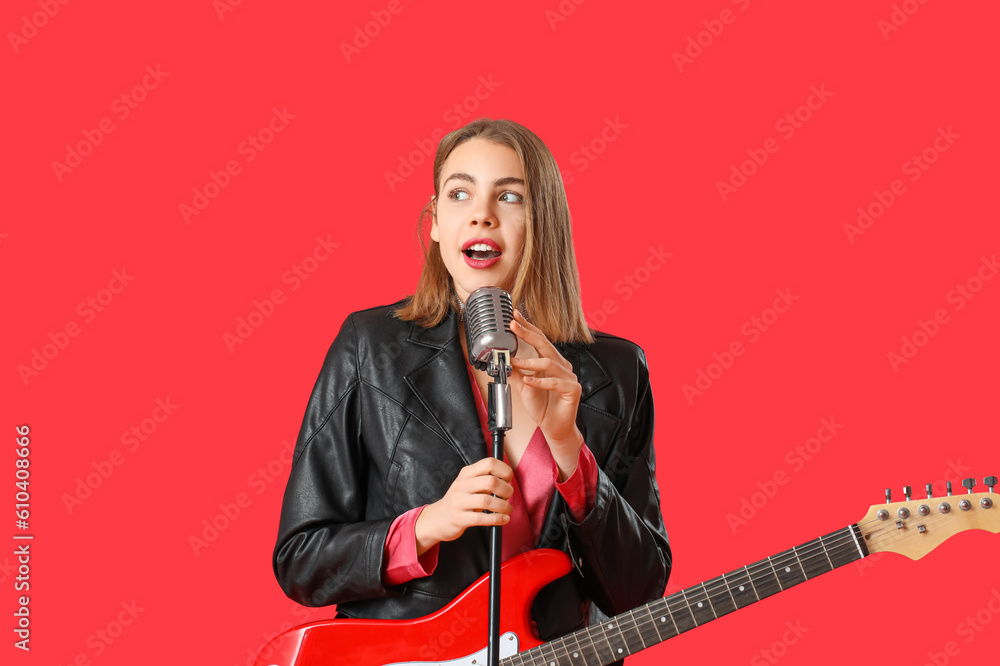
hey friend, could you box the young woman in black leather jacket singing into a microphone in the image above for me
[273,119,670,652]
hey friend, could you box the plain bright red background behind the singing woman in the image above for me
[0,0,1000,666]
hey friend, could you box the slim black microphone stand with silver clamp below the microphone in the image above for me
[486,349,513,666]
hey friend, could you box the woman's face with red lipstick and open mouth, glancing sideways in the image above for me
[431,139,526,303]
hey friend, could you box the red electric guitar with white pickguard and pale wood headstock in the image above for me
[254,477,1000,666]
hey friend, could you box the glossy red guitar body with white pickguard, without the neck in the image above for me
[254,549,571,666]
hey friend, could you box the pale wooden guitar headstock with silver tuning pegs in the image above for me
[858,476,1000,560]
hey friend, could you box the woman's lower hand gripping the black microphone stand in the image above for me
[413,458,514,555]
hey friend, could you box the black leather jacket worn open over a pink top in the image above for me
[273,304,670,639]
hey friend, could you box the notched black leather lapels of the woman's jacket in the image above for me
[402,310,611,465]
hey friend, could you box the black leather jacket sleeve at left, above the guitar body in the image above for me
[272,317,392,606]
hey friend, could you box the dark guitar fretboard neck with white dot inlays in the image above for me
[503,524,868,666]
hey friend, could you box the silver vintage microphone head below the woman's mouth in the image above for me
[465,287,517,376]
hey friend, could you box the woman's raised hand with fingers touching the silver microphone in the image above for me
[510,310,583,474]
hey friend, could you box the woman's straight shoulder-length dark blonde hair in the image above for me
[395,118,594,343]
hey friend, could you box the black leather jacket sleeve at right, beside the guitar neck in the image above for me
[564,348,671,616]
